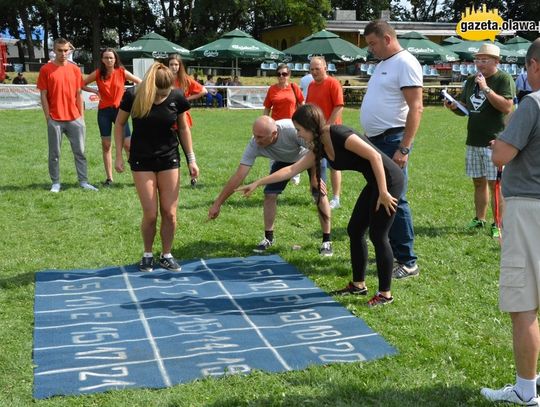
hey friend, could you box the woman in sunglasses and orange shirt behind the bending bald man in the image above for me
[263,64,304,185]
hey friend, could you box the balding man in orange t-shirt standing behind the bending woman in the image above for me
[306,57,345,209]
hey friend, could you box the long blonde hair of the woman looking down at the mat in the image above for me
[131,62,174,118]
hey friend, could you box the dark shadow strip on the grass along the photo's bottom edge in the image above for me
[196,381,484,407]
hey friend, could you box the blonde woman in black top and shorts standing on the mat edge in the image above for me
[114,63,199,271]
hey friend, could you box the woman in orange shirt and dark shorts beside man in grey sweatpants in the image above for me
[83,48,141,187]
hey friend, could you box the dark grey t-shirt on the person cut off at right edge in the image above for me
[499,92,540,199]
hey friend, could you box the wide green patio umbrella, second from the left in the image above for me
[191,30,284,64]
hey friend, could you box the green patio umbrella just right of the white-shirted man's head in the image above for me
[398,31,459,65]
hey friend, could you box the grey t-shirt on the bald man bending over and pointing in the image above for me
[240,119,309,167]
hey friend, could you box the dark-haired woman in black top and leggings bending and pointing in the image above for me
[238,104,403,307]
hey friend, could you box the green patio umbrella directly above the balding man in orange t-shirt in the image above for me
[283,30,367,63]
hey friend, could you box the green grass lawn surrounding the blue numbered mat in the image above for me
[0,107,514,407]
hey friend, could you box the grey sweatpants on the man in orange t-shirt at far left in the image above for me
[47,118,88,184]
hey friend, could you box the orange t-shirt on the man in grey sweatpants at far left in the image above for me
[37,62,84,121]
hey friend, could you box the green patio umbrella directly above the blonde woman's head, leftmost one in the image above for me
[118,32,193,61]
